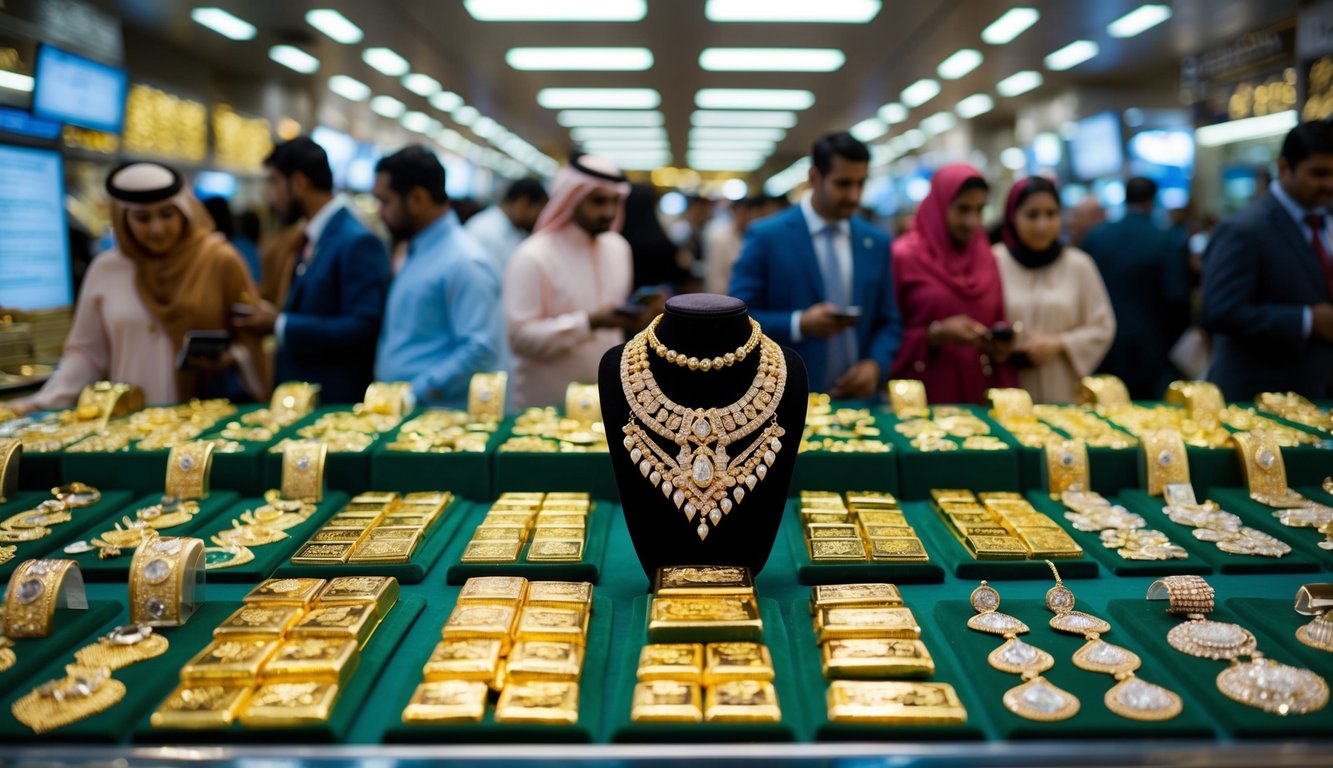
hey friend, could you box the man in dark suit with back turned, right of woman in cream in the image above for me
[1082,177,1189,400]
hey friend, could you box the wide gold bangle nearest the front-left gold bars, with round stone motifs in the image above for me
[129,536,204,627]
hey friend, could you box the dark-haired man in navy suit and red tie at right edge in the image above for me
[1202,120,1333,400]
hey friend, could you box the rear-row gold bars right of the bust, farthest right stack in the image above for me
[930,488,1084,560]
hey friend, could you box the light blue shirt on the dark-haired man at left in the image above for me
[375,209,504,408]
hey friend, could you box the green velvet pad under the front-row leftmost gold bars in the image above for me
[141,595,425,744]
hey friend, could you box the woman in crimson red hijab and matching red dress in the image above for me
[892,163,1017,404]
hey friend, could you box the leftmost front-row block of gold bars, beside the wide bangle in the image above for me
[152,576,399,728]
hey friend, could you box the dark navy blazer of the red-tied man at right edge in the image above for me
[1202,195,1333,400]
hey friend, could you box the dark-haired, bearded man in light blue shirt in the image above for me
[373,145,504,408]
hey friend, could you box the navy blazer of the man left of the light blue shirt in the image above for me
[275,209,389,403]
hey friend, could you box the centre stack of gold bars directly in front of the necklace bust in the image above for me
[629,565,782,723]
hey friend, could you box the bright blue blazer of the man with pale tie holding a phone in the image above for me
[730,205,902,387]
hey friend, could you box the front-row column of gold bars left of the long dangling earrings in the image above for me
[810,584,968,725]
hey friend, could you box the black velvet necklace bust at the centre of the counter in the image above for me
[597,293,808,583]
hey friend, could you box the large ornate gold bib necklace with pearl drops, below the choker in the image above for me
[620,317,786,540]
